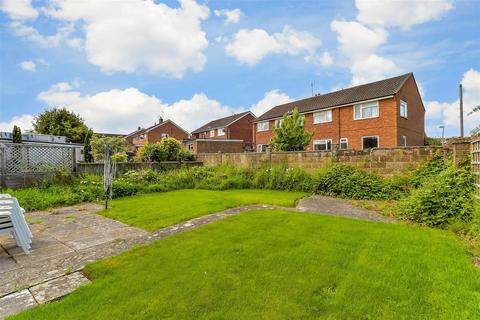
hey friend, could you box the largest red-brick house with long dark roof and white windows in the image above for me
[253,73,425,152]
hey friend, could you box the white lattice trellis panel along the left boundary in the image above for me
[0,143,74,175]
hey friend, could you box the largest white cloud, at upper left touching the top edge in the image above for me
[45,0,209,77]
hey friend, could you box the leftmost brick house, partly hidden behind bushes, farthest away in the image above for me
[125,118,190,152]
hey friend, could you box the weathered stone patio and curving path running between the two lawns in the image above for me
[0,196,392,319]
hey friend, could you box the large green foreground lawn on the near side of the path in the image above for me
[14,210,480,320]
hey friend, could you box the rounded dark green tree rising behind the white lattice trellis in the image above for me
[33,108,89,143]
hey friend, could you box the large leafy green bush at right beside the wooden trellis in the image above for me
[398,159,474,227]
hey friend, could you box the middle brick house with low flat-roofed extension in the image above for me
[184,111,255,154]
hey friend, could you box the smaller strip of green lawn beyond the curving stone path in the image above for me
[99,189,307,230]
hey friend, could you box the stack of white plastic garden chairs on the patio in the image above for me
[0,194,32,254]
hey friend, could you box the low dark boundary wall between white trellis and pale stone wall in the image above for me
[76,161,202,175]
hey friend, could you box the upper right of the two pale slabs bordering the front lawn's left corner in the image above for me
[30,272,90,304]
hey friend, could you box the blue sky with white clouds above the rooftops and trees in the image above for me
[0,0,480,137]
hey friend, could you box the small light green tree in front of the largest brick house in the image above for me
[270,107,314,151]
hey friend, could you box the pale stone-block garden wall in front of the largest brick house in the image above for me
[195,147,451,175]
